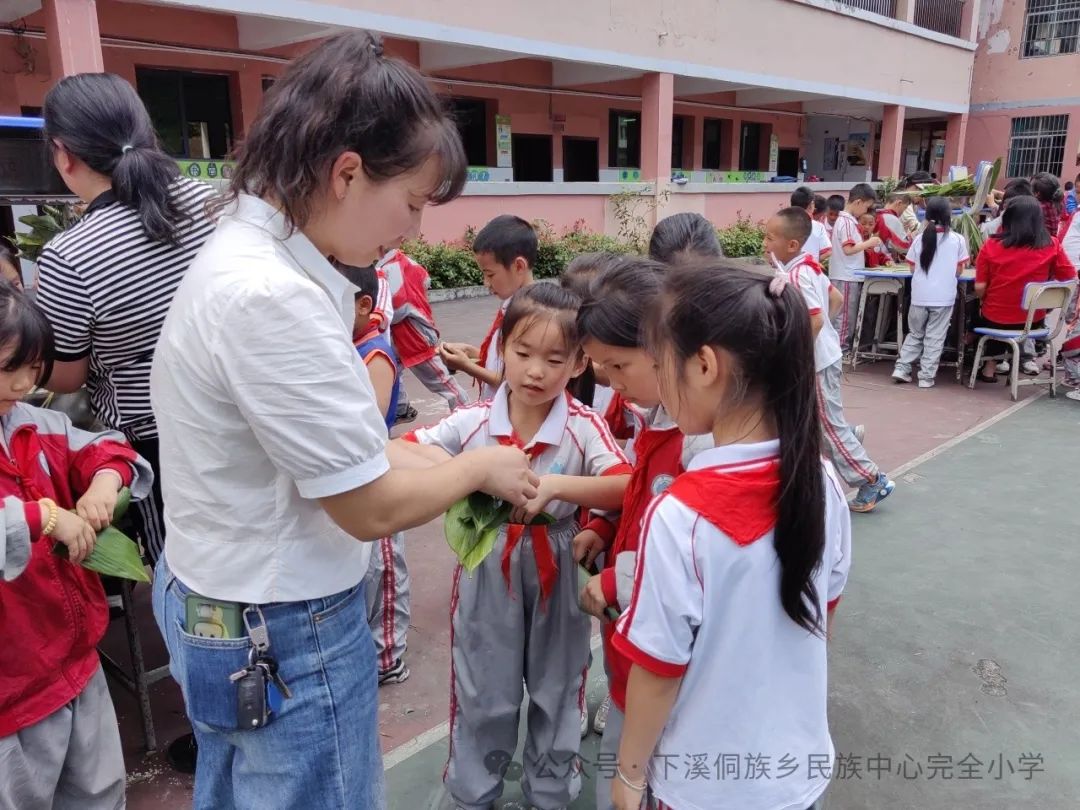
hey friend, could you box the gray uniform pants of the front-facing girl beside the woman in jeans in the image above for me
[445,518,590,810]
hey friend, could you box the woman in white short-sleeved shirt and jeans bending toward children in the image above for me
[151,32,538,810]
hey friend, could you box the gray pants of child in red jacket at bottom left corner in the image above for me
[0,667,126,810]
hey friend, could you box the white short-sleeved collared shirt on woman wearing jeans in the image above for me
[150,195,389,604]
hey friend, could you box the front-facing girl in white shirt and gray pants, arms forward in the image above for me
[399,284,631,810]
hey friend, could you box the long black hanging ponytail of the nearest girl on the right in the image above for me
[766,285,825,633]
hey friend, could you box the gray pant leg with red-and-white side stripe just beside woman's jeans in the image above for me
[365,531,409,672]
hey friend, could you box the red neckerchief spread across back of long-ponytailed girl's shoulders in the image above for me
[667,459,780,545]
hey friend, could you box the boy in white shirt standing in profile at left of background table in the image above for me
[828,189,881,357]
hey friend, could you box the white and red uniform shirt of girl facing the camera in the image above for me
[403,383,631,521]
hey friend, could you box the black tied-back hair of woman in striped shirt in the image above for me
[42,73,187,243]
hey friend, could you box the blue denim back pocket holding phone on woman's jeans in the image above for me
[176,622,251,731]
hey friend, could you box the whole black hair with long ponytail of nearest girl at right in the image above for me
[646,261,825,634]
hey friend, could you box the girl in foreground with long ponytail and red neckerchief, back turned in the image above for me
[612,262,851,810]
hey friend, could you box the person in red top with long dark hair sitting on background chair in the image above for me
[975,197,1077,382]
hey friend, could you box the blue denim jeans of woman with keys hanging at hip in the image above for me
[153,557,386,810]
